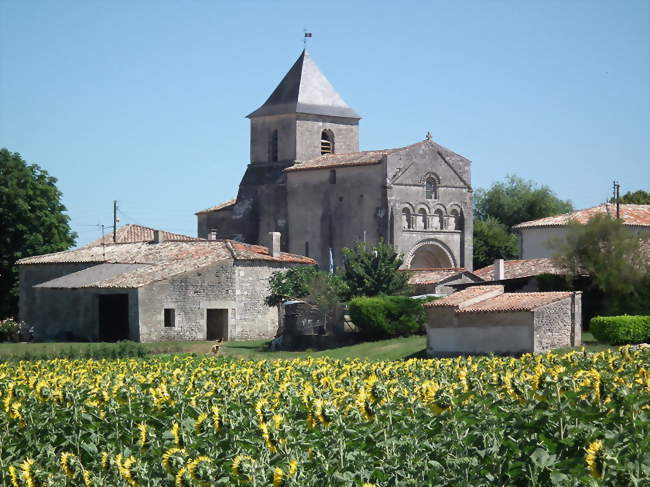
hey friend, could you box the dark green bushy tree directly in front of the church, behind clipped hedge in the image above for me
[342,241,409,298]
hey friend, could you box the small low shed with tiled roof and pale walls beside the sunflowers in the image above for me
[424,285,582,356]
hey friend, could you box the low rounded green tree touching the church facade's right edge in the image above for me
[474,216,519,269]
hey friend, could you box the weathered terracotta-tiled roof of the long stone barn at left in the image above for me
[18,240,316,288]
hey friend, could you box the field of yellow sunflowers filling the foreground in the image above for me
[0,347,650,487]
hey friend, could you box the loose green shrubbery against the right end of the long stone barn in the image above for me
[264,266,346,306]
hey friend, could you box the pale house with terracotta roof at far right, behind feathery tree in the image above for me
[512,203,650,259]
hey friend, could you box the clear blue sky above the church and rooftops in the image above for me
[0,0,650,244]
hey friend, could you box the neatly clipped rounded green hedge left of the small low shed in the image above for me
[350,296,426,339]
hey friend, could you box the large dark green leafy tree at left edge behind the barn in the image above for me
[0,149,76,318]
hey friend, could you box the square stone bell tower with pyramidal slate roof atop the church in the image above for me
[248,51,361,167]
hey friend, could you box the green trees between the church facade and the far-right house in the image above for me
[474,175,573,269]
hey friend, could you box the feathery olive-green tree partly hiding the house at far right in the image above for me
[549,214,650,314]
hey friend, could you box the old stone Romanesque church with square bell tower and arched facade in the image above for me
[196,51,472,270]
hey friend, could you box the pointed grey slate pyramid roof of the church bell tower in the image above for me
[248,49,361,120]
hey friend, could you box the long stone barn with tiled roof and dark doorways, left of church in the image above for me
[18,227,315,342]
